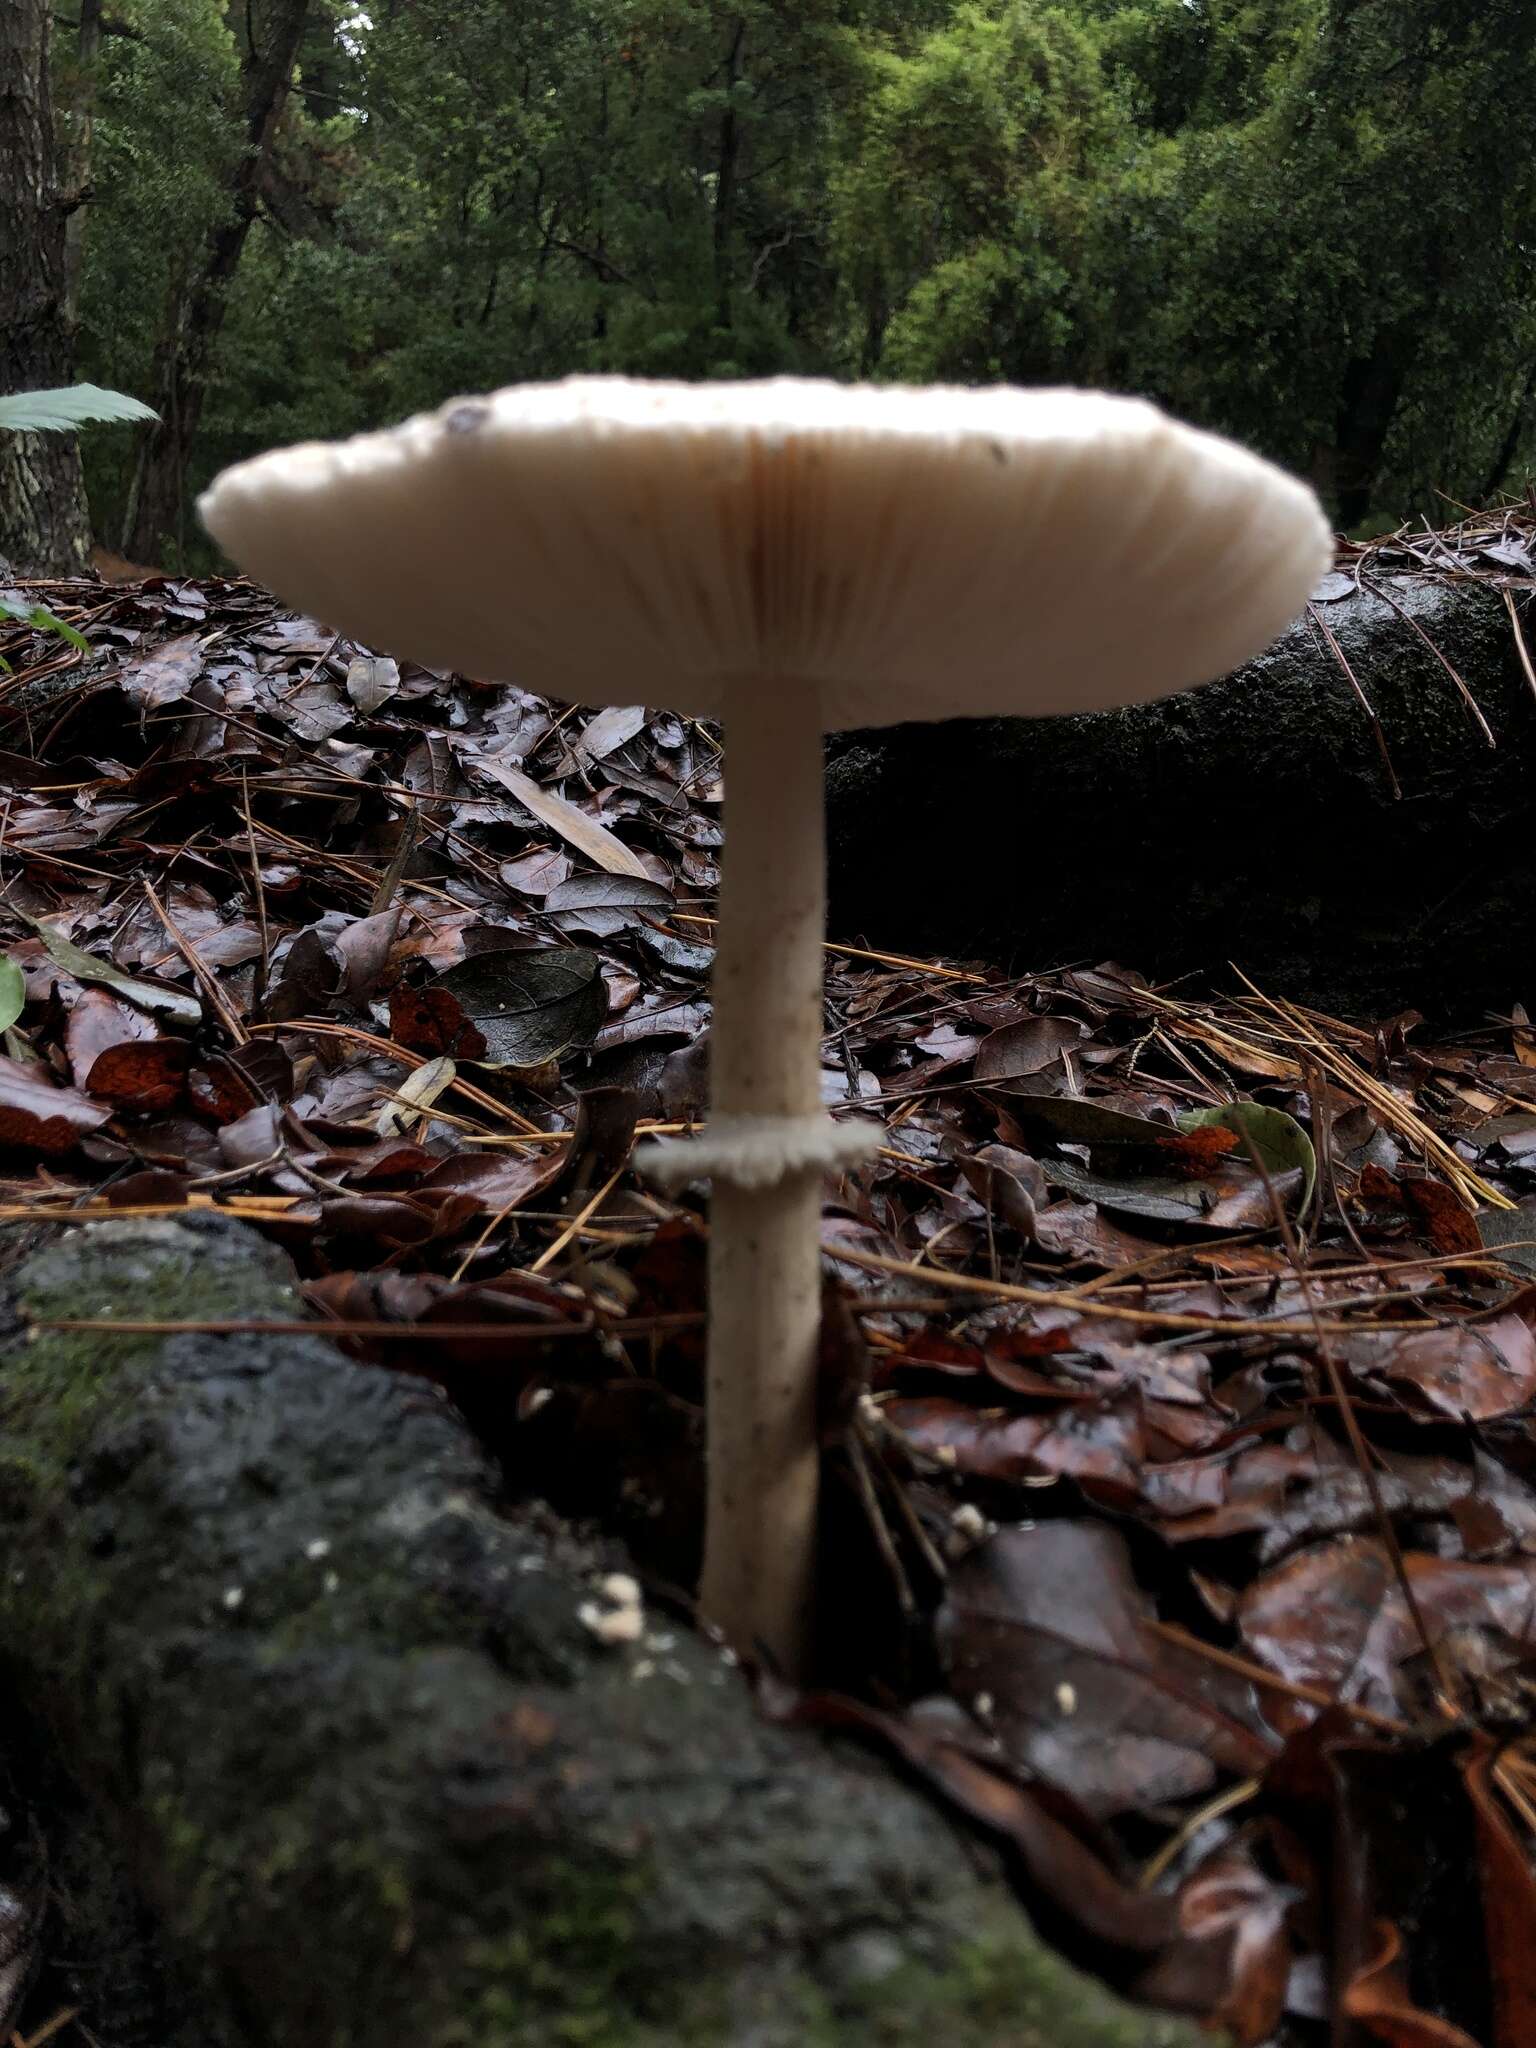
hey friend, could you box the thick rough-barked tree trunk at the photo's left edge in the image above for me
[0,0,90,575]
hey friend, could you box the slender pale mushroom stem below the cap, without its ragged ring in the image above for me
[698,684,827,1677]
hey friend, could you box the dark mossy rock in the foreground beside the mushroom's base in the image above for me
[0,1217,1194,2048]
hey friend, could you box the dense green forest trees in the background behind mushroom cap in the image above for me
[0,0,1536,563]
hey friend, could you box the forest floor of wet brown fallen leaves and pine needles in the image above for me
[0,561,1536,2048]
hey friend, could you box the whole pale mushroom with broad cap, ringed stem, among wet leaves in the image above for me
[201,377,1331,1675]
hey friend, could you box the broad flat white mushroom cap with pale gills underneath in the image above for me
[201,377,1331,729]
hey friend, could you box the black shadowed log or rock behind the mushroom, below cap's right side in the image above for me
[827,575,1536,1018]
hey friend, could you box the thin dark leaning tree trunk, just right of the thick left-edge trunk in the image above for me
[123,0,313,561]
